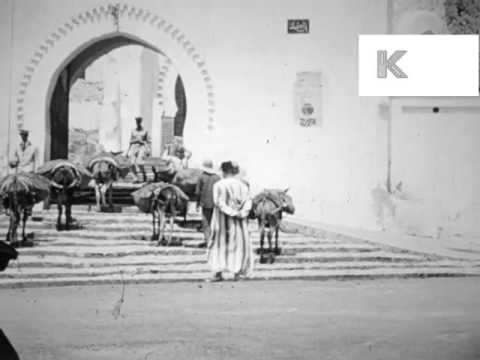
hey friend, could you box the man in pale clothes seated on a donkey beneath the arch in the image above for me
[127,117,151,182]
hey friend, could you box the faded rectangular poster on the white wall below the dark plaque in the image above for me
[294,72,322,128]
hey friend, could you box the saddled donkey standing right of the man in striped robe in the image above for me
[251,189,295,263]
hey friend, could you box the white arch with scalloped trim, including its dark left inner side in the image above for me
[16,4,215,165]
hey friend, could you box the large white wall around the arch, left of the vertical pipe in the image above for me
[0,0,438,233]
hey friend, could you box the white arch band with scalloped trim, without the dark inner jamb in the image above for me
[15,4,215,165]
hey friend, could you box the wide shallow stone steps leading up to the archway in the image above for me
[0,201,480,287]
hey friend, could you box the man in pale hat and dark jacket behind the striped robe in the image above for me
[196,160,220,246]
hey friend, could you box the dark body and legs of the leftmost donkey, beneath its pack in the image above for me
[2,191,34,247]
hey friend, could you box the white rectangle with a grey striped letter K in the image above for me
[358,35,479,96]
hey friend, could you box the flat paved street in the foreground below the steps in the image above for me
[0,278,480,360]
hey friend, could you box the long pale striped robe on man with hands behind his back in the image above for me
[208,177,254,276]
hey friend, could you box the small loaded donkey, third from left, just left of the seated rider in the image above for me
[90,158,119,211]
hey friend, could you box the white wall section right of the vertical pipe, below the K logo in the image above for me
[392,98,480,237]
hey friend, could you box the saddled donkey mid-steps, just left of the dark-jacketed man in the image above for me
[151,184,189,245]
